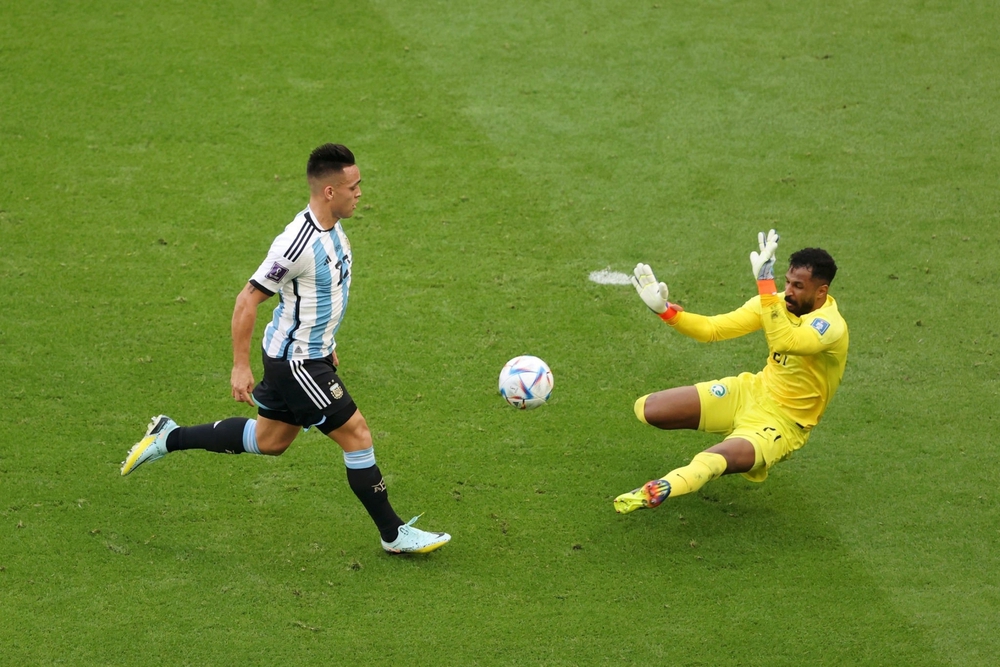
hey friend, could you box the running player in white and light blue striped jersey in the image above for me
[121,144,451,553]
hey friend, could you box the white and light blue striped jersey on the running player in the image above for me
[250,207,352,360]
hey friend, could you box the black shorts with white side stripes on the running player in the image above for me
[253,354,358,433]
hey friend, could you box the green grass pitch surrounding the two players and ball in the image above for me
[0,0,1000,666]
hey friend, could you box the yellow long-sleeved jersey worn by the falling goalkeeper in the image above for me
[669,294,848,427]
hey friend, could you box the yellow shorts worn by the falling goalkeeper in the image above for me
[695,373,809,482]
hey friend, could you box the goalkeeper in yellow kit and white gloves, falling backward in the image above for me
[615,229,848,514]
